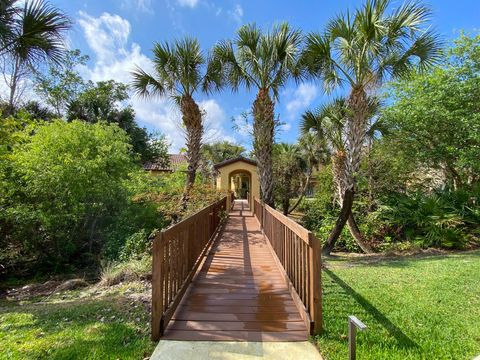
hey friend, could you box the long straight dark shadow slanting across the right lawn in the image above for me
[323,268,419,348]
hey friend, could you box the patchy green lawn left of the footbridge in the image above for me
[0,284,154,359]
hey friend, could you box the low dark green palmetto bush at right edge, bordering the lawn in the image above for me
[367,186,480,249]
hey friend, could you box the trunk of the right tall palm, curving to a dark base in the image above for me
[323,88,368,255]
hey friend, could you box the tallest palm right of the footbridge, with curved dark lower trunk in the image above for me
[301,0,440,254]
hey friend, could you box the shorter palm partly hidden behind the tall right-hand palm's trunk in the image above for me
[301,98,380,253]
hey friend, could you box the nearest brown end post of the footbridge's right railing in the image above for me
[308,232,322,334]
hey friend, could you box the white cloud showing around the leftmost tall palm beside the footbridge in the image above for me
[80,12,240,152]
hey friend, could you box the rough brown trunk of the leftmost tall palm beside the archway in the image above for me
[180,95,203,209]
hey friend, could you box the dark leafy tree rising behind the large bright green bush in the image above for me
[67,80,167,161]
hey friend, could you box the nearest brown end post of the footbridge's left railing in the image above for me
[151,232,164,341]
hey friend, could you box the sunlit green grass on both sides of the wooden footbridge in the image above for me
[0,251,480,360]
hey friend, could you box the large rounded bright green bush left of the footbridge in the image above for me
[0,121,165,270]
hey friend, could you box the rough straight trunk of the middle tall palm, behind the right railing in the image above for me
[253,89,275,207]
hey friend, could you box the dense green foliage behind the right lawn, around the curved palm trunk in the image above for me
[304,35,480,250]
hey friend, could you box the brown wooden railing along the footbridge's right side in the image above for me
[253,198,322,334]
